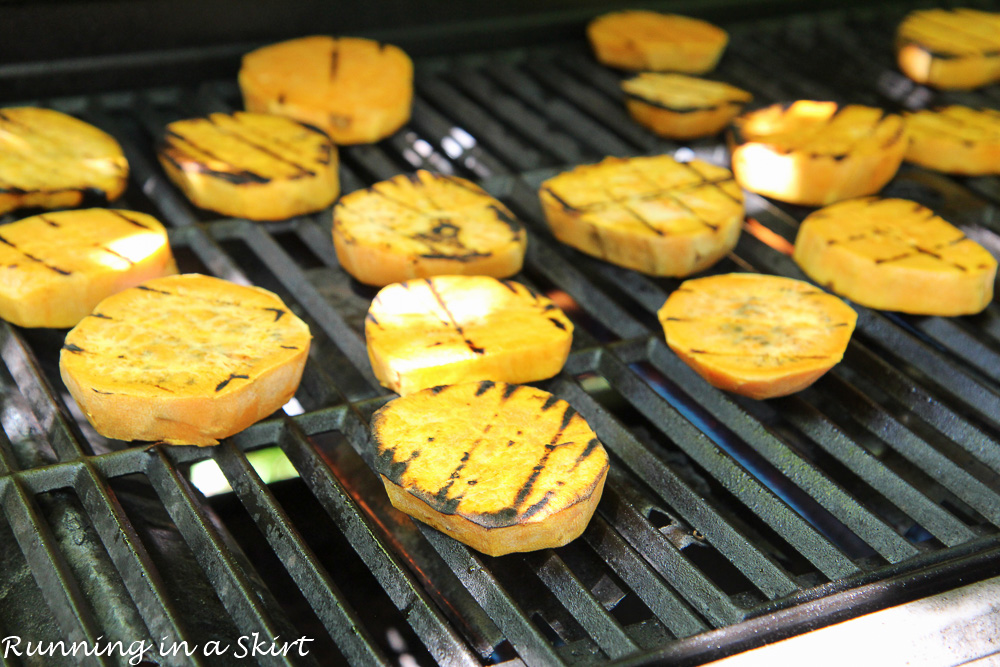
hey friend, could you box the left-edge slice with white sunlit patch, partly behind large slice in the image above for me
[0,208,177,328]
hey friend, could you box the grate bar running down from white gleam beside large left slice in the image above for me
[278,421,477,665]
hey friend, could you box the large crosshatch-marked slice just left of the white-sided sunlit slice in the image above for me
[539,155,743,276]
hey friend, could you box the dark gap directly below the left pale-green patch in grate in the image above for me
[201,480,344,662]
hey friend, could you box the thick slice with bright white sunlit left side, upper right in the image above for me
[732,100,907,206]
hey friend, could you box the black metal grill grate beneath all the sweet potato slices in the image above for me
[0,2,1000,666]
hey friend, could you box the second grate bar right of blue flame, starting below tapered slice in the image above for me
[775,398,976,546]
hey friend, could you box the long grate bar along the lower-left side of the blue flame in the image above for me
[584,355,858,580]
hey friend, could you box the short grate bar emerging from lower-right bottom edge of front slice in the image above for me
[526,550,639,659]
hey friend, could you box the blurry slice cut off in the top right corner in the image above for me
[896,8,1000,90]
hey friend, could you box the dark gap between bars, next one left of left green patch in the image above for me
[108,474,241,646]
